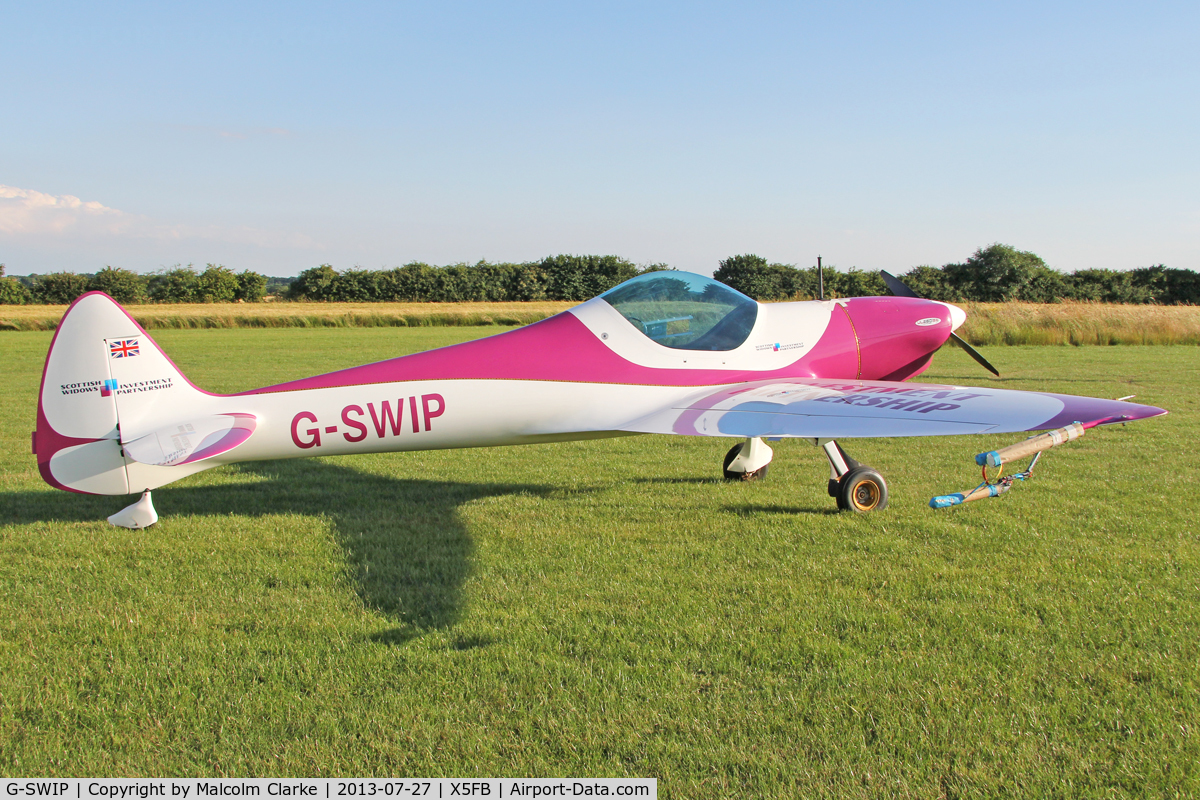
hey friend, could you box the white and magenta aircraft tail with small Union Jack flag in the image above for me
[34,291,254,494]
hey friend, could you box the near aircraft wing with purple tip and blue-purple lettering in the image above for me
[619,378,1166,439]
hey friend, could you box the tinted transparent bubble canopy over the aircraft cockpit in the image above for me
[600,270,758,351]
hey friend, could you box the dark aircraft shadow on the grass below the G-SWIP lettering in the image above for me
[0,459,557,646]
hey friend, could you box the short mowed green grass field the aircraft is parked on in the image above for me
[0,329,1200,798]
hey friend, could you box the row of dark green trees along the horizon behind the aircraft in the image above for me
[0,245,1200,305]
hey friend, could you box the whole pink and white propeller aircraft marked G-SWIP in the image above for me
[34,271,1165,528]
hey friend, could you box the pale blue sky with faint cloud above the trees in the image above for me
[0,2,1200,275]
